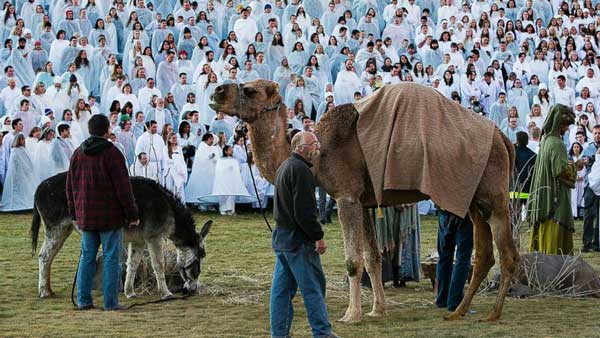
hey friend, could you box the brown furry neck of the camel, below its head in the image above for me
[248,103,292,183]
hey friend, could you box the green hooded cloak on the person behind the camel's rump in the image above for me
[527,104,577,232]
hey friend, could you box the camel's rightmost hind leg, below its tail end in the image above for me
[487,204,519,322]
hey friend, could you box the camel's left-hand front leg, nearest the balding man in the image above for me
[338,198,364,323]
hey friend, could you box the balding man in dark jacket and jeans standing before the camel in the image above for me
[270,132,337,337]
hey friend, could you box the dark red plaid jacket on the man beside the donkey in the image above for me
[66,141,138,231]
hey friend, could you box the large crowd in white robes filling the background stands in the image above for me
[0,0,600,213]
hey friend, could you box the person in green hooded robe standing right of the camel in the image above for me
[527,104,583,255]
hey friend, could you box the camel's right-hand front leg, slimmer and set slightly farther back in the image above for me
[362,208,387,317]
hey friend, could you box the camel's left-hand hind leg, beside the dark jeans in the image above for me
[444,206,494,320]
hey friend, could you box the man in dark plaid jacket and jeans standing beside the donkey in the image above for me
[66,115,139,310]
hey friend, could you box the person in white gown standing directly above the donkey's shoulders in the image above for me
[163,133,187,203]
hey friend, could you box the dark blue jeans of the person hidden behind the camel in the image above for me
[435,210,473,311]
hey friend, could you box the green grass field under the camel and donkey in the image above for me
[0,213,600,337]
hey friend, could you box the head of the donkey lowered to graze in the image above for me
[177,220,212,293]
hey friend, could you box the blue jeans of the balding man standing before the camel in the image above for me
[269,244,331,338]
